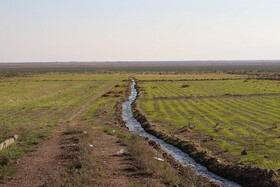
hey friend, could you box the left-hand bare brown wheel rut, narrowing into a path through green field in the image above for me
[0,85,115,186]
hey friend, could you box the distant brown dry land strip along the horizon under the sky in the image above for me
[0,60,280,71]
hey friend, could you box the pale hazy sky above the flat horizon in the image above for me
[0,0,280,62]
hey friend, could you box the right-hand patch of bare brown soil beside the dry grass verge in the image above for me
[87,128,165,186]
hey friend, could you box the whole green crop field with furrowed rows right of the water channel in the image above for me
[136,74,280,171]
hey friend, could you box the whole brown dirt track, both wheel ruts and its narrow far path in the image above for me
[0,85,164,186]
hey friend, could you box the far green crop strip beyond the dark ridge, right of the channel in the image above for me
[140,80,280,99]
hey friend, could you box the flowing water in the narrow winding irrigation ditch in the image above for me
[122,80,240,187]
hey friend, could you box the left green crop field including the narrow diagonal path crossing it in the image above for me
[0,73,127,160]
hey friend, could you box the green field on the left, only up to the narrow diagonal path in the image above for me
[0,73,124,140]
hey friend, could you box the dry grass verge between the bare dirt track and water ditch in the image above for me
[103,127,198,186]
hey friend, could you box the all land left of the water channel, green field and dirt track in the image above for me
[0,72,203,187]
